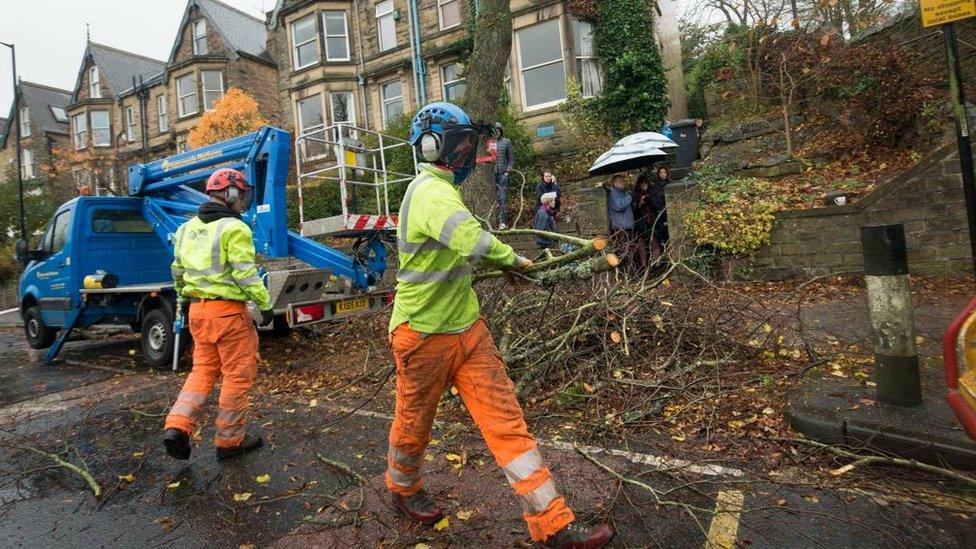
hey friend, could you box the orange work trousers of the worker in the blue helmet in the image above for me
[386,320,573,541]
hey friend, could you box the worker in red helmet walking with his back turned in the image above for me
[163,169,274,460]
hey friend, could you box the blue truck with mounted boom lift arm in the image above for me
[17,127,392,369]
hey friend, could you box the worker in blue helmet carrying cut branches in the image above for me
[385,103,613,549]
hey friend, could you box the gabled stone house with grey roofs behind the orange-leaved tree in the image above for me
[68,0,280,194]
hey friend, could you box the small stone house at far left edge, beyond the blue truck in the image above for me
[0,81,71,188]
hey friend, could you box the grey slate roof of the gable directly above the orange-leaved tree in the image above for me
[169,0,274,63]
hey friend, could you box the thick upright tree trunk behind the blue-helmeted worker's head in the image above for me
[461,0,512,218]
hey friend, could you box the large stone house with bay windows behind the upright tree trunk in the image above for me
[268,0,686,151]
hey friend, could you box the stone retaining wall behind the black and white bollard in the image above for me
[666,143,972,279]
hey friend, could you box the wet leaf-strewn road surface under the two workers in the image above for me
[0,324,976,548]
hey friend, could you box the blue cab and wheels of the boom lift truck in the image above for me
[20,197,175,364]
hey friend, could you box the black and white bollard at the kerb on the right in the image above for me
[861,224,922,406]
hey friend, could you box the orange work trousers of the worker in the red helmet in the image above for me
[165,300,261,448]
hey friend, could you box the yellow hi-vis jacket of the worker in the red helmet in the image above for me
[172,217,272,311]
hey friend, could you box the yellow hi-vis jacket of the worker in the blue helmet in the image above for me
[389,164,515,334]
